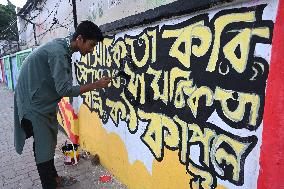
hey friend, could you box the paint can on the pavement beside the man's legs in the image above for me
[62,140,79,165]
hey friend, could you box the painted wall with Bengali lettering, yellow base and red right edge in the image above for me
[58,0,284,189]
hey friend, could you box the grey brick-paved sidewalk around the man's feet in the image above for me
[0,83,127,189]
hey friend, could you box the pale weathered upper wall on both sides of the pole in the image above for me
[17,0,182,49]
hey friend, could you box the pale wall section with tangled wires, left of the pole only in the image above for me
[18,0,74,48]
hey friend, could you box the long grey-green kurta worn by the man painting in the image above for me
[14,38,80,163]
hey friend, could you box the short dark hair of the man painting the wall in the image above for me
[72,20,104,42]
